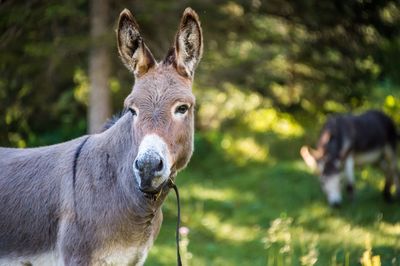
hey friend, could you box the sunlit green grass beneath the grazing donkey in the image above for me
[146,133,400,265]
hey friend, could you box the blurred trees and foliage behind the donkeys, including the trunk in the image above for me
[0,0,400,147]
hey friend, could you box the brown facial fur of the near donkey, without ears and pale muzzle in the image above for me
[125,64,195,170]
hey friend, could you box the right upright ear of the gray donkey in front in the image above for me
[174,7,203,78]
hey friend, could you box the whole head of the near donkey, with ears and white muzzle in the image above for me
[117,8,203,193]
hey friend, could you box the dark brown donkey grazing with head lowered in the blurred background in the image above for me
[300,110,400,207]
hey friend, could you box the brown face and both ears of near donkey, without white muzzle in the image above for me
[117,8,203,175]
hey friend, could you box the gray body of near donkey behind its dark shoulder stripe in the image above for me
[0,139,83,260]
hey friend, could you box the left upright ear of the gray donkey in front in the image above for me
[117,9,156,78]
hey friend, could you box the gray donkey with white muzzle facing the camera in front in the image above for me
[0,8,203,265]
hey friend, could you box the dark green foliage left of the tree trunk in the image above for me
[0,0,88,146]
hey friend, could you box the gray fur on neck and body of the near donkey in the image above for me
[0,113,162,265]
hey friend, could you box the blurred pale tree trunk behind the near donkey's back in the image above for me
[88,0,111,133]
